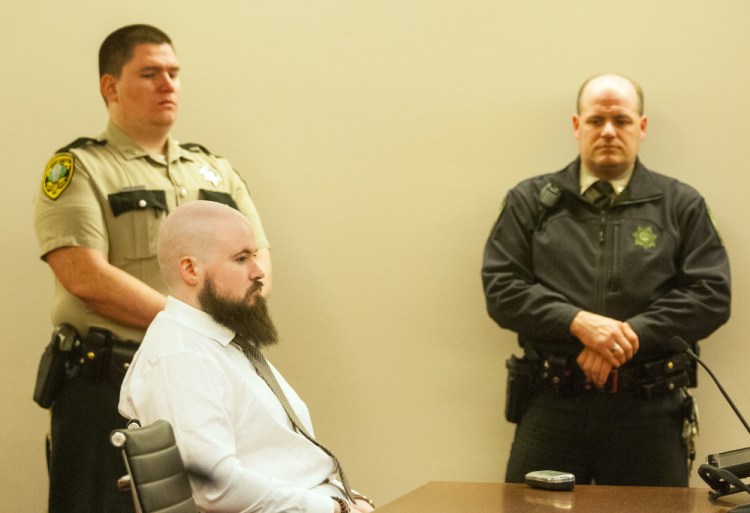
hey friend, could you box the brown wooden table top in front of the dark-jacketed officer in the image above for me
[376,481,750,513]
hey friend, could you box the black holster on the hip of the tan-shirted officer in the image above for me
[34,324,81,408]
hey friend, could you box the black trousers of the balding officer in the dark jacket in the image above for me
[505,386,689,486]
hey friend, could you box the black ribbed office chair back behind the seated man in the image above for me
[110,420,198,513]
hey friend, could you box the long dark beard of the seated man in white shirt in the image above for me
[198,277,279,349]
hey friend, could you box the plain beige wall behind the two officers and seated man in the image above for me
[0,0,750,512]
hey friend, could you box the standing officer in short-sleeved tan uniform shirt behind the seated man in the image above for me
[34,25,271,513]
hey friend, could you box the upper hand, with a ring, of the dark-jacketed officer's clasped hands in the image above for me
[570,310,638,368]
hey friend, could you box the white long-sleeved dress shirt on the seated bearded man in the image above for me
[119,297,341,513]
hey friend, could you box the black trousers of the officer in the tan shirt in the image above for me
[48,376,134,513]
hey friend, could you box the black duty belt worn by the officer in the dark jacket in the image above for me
[539,354,695,399]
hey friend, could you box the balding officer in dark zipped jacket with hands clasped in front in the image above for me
[482,74,730,486]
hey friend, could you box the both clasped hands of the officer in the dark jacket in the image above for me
[570,310,638,387]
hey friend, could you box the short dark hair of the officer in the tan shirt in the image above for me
[99,25,174,78]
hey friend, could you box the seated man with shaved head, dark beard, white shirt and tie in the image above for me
[119,201,372,513]
